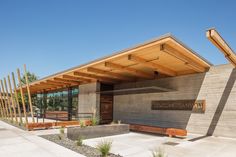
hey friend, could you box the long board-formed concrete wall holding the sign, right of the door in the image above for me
[114,64,236,137]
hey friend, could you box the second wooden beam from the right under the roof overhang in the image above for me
[128,55,177,76]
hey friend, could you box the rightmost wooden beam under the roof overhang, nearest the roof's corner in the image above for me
[160,44,206,72]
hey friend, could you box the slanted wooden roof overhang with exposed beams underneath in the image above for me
[23,34,211,93]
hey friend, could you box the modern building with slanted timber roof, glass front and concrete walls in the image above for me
[21,29,236,137]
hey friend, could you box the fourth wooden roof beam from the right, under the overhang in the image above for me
[87,67,132,81]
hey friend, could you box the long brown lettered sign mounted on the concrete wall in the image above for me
[152,100,206,113]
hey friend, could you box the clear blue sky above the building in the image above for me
[0,0,236,78]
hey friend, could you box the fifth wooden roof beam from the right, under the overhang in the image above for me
[73,72,116,83]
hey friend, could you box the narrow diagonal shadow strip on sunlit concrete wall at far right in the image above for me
[207,69,236,135]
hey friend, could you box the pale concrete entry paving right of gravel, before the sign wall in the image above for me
[84,133,236,157]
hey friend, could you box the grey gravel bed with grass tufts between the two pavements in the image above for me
[40,134,122,157]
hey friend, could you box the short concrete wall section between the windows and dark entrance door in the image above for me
[78,83,100,116]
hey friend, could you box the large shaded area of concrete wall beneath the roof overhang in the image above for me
[114,73,206,129]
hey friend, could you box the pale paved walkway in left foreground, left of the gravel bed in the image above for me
[0,121,84,157]
